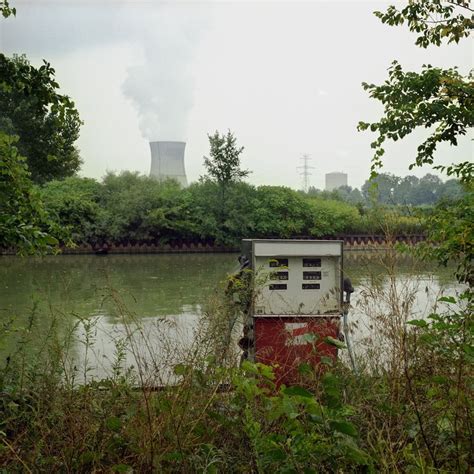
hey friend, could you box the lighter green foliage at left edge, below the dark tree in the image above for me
[0,132,65,254]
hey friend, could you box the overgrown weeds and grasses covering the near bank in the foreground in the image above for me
[0,275,473,473]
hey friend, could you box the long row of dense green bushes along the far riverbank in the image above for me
[41,172,428,245]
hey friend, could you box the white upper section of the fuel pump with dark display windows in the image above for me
[242,239,343,316]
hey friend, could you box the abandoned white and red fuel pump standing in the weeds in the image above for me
[241,239,343,384]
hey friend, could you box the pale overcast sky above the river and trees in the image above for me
[0,0,473,188]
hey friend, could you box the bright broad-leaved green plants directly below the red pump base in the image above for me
[233,362,373,473]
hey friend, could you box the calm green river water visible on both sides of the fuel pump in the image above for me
[0,251,458,382]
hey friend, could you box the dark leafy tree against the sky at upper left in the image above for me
[0,54,81,183]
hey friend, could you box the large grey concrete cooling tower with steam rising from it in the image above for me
[150,142,188,187]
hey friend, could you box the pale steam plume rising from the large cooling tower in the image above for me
[123,5,202,141]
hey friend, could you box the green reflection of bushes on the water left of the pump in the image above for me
[0,254,237,319]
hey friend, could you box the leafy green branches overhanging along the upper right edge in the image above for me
[359,0,474,278]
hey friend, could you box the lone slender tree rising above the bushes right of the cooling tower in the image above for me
[204,130,250,226]
